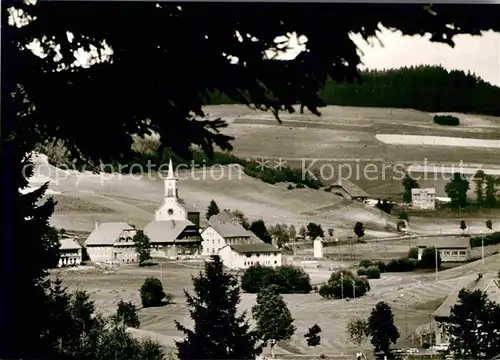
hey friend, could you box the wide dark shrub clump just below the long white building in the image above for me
[241,265,312,294]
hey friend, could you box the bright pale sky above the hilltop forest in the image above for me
[282,28,500,86]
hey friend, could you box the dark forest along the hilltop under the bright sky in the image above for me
[208,65,500,116]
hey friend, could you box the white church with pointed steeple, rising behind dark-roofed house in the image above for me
[155,159,200,228]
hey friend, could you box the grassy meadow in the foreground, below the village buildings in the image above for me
[59,255,500,355]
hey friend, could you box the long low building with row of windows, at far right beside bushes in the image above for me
[417,236,471,262]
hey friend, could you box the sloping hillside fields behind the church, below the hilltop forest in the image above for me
[32,105,500,238]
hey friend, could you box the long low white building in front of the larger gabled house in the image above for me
[218,243,282,270]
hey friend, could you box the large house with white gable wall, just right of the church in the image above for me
[201,210,262,256]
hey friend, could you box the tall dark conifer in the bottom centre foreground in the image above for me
[175,256,262,360]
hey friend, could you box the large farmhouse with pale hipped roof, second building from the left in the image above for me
[85,222,137,263]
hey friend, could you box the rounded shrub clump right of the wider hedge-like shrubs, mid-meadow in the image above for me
[319,270,370,299]
